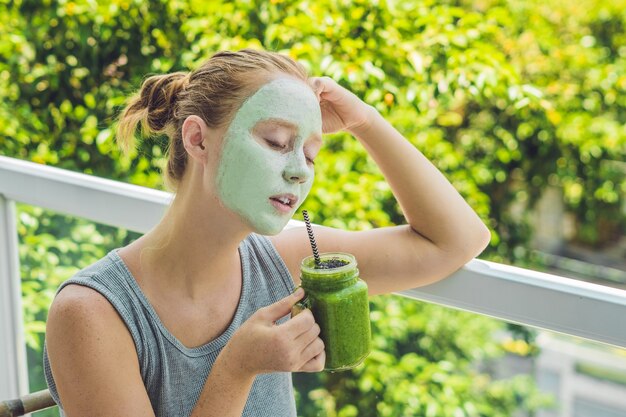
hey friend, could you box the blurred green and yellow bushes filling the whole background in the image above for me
[0,0,626,417]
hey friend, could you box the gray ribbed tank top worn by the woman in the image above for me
[43,233,296,417]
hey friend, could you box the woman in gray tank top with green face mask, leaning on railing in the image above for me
[44,50,490,417]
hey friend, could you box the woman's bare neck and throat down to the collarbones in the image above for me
[125,187,251,301]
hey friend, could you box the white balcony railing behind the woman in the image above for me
[0,156,626,399]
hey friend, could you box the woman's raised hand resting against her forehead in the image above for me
[308,77,374,133]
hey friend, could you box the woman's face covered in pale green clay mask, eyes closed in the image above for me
[217,78,322,235]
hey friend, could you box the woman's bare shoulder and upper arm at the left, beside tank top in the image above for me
[44,276,146,414]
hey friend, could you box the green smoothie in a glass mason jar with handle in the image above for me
[300,252,371,371]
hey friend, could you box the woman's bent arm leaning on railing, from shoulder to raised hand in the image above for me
[271,77,490,295]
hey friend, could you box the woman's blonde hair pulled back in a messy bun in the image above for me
[116,49,308,191]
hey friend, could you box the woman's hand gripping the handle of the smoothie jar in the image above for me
[220,288,326,375]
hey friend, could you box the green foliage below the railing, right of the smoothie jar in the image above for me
[294,296,549,417]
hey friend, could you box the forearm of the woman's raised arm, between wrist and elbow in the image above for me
[351,106,490,257]
